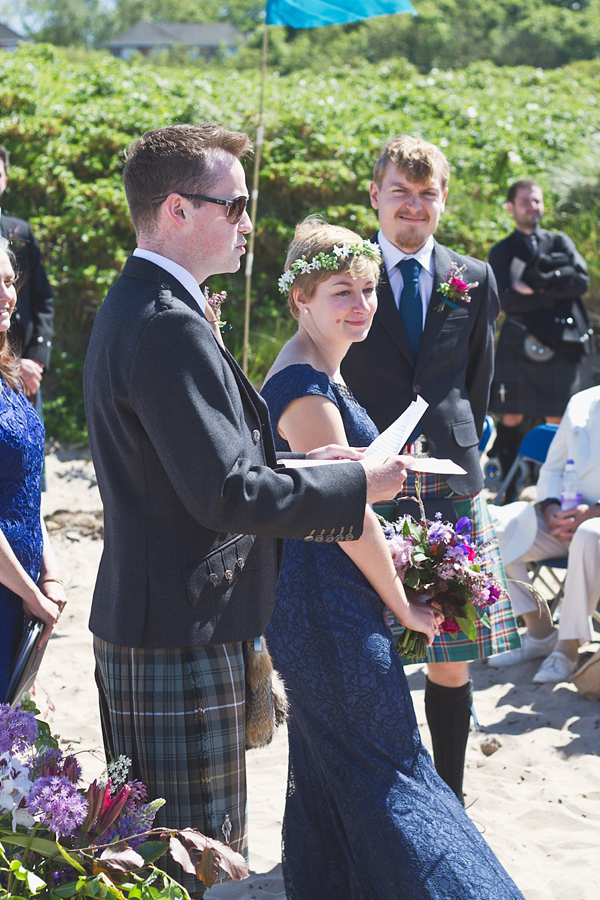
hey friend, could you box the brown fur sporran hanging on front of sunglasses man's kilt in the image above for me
[246,637,288,750]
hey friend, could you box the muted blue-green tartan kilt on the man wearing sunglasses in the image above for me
[94,637,248,896]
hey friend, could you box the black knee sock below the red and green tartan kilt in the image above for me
[425,678,473,803]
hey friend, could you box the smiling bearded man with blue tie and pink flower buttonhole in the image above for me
[342,135,516,799]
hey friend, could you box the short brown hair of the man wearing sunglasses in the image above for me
[123,122,252,234]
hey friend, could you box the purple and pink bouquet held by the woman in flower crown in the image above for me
[381,508,505,659]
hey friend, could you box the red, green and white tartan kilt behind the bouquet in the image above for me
[384,472,521,662]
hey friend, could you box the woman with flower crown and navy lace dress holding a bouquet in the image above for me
[262,219,522,900]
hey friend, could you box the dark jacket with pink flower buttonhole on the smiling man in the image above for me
[342,241,500,494]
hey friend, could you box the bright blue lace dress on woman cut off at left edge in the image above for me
[0,379,44,702]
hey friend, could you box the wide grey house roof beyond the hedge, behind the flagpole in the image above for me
[107,22,243,48]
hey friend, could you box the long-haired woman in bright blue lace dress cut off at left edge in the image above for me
[0,239,66,702]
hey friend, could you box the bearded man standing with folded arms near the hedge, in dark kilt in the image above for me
[490,178,594,486]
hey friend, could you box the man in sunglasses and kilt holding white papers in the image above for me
[84,125,412,893]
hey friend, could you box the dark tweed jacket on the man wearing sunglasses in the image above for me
[84,257,366,647]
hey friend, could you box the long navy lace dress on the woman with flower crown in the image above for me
[262,364,522,900]
